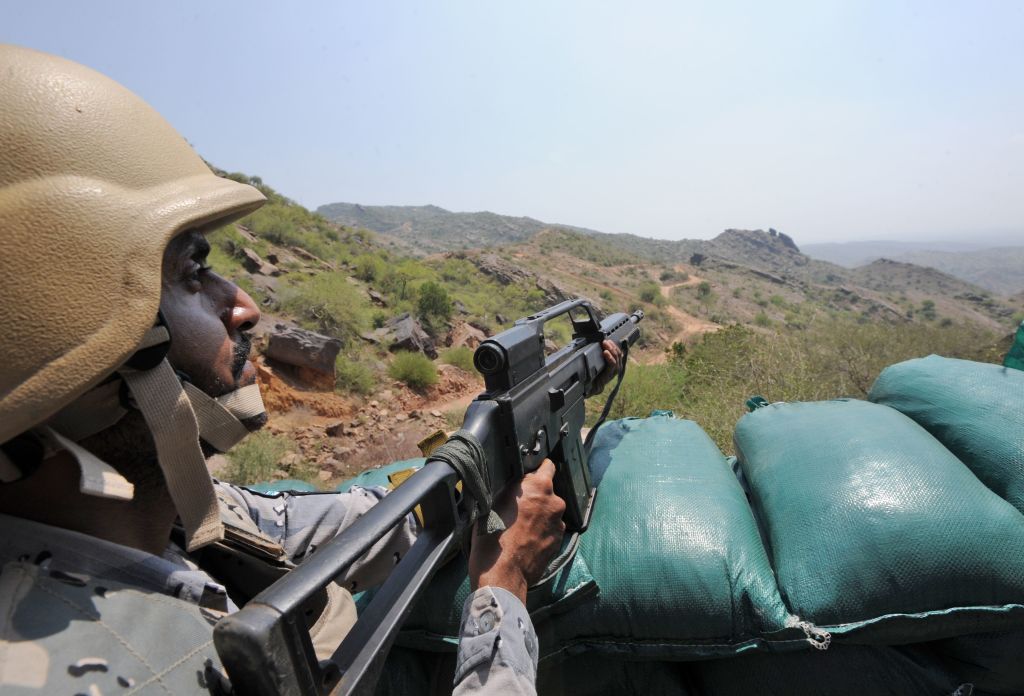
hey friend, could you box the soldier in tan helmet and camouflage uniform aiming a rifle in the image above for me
[0,46,618,694]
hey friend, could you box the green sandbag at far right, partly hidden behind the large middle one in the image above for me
[868,355,1024,512]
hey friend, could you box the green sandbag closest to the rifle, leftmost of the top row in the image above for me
[541,417,790,659]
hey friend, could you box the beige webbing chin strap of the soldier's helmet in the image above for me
[48,325,265,551]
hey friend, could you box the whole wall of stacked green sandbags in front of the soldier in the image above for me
[346,357,1024,694]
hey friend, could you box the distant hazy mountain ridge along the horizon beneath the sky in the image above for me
[316,203,1024,296]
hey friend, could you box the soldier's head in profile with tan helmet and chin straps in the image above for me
[0,45,265,547]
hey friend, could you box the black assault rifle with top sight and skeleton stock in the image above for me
[213,300,643,696]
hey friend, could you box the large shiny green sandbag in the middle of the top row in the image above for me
[735,400,1024,643]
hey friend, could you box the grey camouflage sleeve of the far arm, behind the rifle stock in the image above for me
[216,481,419,593]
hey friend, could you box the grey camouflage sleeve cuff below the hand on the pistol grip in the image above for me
[454,588,538,696]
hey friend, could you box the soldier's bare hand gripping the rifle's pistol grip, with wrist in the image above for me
[469,460,565,603]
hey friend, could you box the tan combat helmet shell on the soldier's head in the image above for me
[0,45,264,442]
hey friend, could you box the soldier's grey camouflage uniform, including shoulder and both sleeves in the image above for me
[0,483,537,696]
